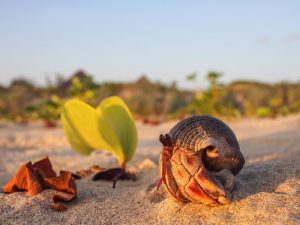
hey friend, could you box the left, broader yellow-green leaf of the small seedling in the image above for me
[61,99,124,161]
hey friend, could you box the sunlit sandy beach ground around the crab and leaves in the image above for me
[0,115,300,225]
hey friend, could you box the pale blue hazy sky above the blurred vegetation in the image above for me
[0,0,300,88]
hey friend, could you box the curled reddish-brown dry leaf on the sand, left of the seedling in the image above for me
[3,157,77,211]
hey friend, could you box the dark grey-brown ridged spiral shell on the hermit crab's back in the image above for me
[169,115,245,174]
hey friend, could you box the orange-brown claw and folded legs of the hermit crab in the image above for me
[172,148,233,205]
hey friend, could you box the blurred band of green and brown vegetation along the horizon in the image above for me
[0,71,300,126]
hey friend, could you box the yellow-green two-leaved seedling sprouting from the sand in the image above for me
[61,96,137,169]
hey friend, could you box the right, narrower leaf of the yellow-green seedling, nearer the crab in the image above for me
[97,96,138,162]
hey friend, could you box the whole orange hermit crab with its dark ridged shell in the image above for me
[157,115,245,206]
